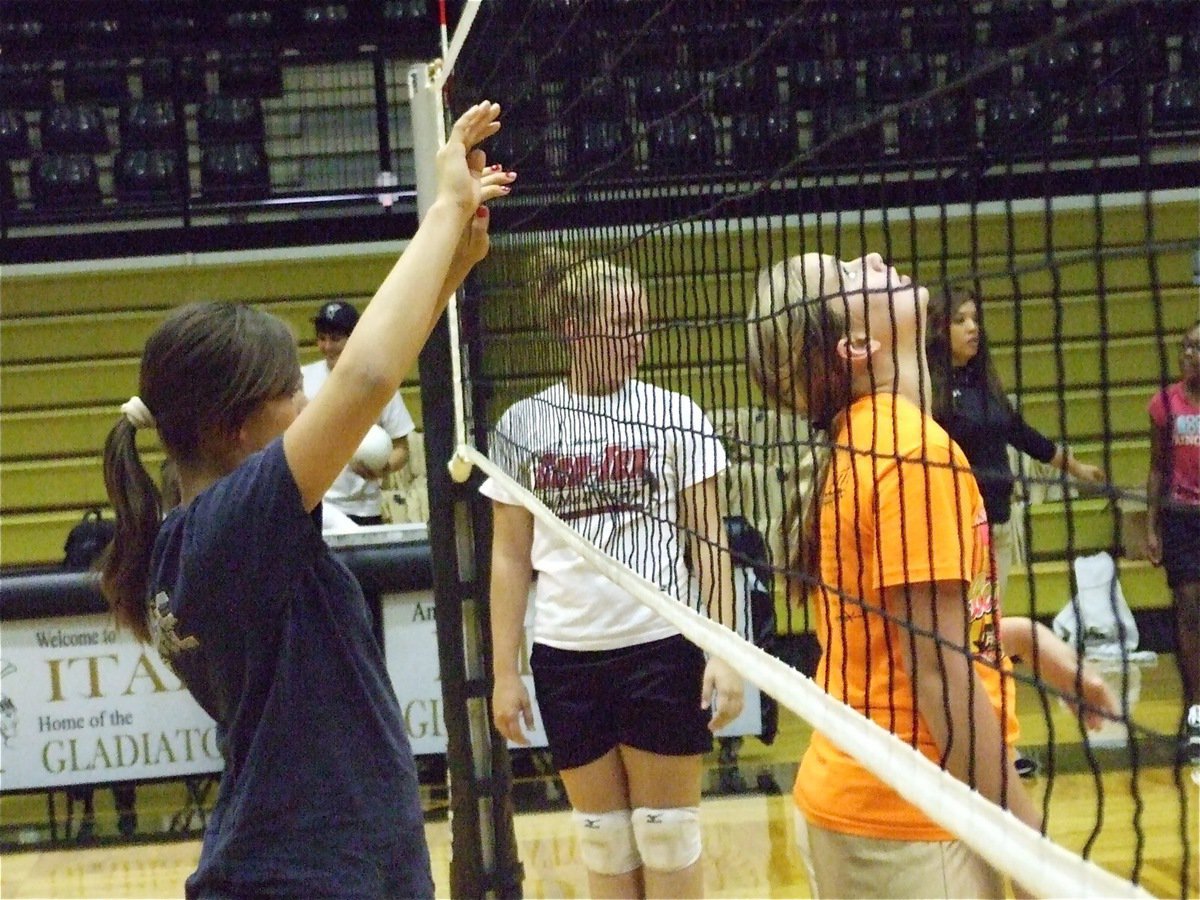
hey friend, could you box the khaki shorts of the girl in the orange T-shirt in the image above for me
[796,810,1006,900]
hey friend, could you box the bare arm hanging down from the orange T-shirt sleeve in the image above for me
[884,582,1042,829]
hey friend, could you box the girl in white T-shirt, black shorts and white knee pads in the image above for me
[481,252,742,896]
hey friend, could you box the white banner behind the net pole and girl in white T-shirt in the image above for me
[382,590,762,755]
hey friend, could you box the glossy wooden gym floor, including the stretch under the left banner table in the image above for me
[0,655,1200,898]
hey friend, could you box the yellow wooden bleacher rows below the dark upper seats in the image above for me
[0,199,1198,643]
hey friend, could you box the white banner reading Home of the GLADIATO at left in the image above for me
[0,614,223,791]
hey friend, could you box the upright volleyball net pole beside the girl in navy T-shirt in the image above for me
[407,64,522,898]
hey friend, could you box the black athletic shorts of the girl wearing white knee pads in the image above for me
[529,635,713,769]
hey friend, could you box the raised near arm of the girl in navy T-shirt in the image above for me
[283,103,499,509]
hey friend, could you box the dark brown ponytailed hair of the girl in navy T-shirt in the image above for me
[101,302,300,641]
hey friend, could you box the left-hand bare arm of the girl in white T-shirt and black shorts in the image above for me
[491,502,533,744]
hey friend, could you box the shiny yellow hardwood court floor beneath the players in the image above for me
[0,656,1200,899]
